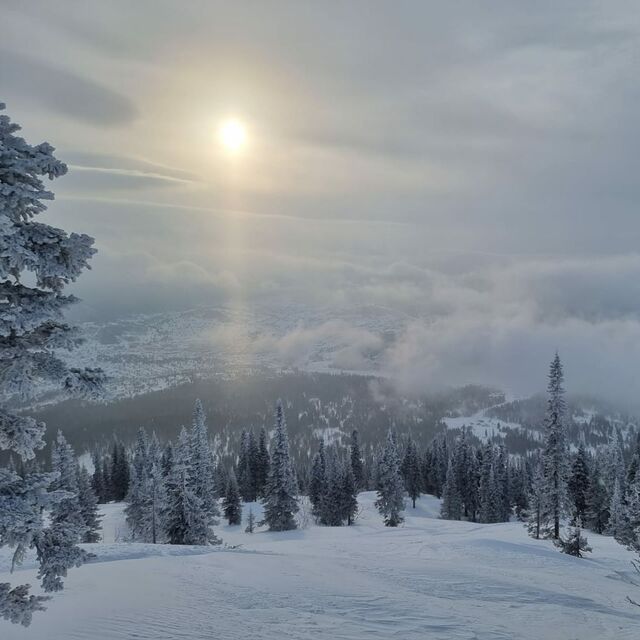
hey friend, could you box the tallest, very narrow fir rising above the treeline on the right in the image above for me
[542,353,568,540]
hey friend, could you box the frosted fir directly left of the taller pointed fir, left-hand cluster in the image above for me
[162,427,220,545]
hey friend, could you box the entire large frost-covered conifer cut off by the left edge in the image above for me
[0,103,104,626]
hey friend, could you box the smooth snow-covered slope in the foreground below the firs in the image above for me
[0,493,640,640]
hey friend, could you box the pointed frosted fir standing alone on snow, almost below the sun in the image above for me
[264,400,299,531]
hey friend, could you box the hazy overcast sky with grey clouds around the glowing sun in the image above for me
[0,0,640,400]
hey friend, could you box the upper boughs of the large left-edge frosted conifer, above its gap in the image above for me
[0,103,102,458]
